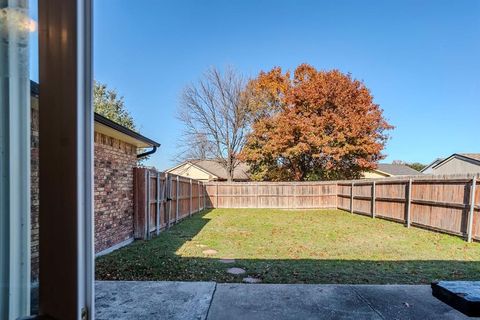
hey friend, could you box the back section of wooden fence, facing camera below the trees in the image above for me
[205,182,337,209]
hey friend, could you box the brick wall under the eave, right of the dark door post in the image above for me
[94,132,137,252]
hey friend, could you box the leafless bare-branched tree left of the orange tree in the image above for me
[178,68,249,181]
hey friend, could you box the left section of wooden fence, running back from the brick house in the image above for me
[134,167,206,239]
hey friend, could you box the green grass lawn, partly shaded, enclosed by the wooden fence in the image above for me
[96,209,480,283]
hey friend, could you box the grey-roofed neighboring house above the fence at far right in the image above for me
[422,153,480,175]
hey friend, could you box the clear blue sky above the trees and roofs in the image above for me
[30,0,480,169]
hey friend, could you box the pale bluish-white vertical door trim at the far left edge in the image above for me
[0,0,30,319]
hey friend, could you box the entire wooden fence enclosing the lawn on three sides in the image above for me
[134,172,480,241]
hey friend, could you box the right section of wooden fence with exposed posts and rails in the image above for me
[337,176,480,241]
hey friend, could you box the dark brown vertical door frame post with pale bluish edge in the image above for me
[38,0,94,320]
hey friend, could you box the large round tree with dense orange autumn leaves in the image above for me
[241,64,393,181]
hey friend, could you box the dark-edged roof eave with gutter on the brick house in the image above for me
[30,81,160,148]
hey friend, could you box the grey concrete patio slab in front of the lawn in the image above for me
[95,281,472,320]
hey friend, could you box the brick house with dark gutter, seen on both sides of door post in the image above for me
[30,81,160,282]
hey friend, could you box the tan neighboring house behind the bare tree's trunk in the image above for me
[165,160,250,182]
